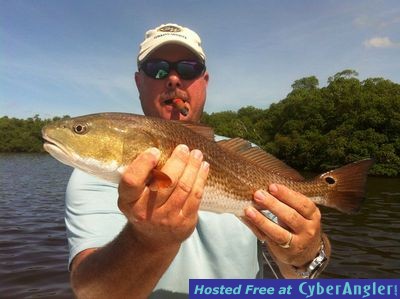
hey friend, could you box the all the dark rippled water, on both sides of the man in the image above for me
[0,154,400,299]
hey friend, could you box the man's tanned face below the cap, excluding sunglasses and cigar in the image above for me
[135,44,208,122]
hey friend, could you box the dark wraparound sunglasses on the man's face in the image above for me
[139,59,206,80]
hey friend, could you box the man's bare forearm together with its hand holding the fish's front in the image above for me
[71,145,208,298]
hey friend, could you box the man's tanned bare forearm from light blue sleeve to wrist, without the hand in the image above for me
[71,225,179,298]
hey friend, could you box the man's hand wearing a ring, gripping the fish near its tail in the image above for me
[244,184,321,267]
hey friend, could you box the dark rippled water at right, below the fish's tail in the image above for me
[321,178,400,278]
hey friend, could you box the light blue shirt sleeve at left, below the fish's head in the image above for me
[65,169,126,268]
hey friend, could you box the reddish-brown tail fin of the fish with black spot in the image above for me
[318,159,374,214]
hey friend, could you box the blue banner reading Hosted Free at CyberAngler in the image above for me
[189,279,400,299]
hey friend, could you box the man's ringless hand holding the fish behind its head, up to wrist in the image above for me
[118,145,209,250]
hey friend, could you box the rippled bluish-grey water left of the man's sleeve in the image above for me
[0,154,73,298]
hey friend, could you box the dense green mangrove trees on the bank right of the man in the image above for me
[203,70,400,176]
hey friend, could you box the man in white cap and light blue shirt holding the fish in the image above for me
[66,24,329,298]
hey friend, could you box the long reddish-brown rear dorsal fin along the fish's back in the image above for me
[218,138,304,181]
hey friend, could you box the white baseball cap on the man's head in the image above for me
[137,23,206,65]
